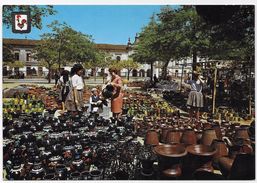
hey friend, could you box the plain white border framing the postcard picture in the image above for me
[0,0,257,183]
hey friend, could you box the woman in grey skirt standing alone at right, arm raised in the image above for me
[184,72,204,120]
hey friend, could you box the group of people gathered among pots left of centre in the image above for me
[55,64,123,118]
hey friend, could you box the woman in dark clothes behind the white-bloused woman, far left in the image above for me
[57,70,71,111]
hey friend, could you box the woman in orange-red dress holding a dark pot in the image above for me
[109,68,123,118]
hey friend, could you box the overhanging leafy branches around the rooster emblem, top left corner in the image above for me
[3,5,57,29]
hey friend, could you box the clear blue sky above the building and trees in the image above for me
[3,5,177,44]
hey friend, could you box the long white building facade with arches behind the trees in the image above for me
[3,35,196,77]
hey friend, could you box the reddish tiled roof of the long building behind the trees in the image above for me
[3,38,127,52]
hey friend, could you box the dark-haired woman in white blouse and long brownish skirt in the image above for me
[68,64,85,111]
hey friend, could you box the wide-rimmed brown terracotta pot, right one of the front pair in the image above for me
[183,144,217,177]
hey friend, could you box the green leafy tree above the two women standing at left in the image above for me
[41,21,95,70]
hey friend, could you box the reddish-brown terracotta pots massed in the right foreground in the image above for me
[145,116,254,179]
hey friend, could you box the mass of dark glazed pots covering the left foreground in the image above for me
[3,109,136,180]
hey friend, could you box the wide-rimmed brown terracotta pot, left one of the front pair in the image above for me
[154,144,187,179]
